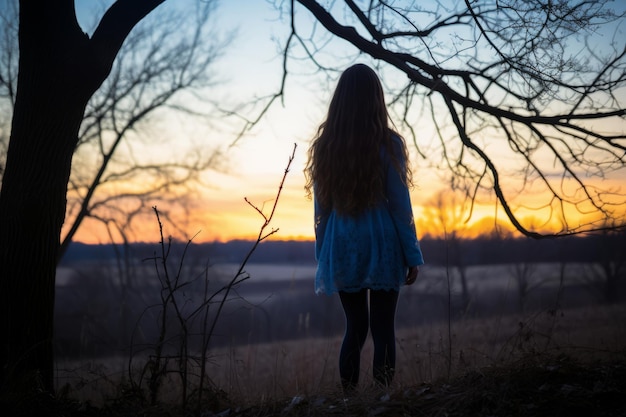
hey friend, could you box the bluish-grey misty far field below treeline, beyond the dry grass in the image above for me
[56,264,626,352]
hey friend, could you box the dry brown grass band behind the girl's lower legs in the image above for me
[58,305,626,404]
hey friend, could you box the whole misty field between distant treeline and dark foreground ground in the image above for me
[56,264,626,410]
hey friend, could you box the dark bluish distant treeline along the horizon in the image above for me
[61,232,626,266]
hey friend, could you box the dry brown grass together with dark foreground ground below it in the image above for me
[0,305,626,417]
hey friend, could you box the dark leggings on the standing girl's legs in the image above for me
[339,289,398,391]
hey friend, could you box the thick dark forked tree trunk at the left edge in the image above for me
[0,0,163,393]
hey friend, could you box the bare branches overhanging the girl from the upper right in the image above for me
[277,0,626,237]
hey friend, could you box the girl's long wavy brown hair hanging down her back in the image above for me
[304,64,411,216]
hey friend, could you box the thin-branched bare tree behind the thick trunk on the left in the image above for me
[0,1,226,258]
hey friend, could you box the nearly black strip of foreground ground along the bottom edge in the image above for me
[0,352,626,417]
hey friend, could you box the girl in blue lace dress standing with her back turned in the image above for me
[305,64,424,392]
